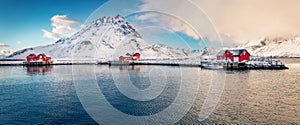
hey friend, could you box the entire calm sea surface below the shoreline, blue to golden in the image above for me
[0,59,300,124]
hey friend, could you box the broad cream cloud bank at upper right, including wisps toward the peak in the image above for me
[140,0,300,44]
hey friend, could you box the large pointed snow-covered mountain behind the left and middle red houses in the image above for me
[8,15,202,60]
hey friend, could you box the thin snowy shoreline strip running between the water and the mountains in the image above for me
[0,58,288,70]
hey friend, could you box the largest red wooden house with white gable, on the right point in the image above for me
[217,49,251,63]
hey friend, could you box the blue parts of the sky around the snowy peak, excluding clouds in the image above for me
[0,0,209,50]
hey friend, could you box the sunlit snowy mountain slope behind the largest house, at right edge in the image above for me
[239,37,300,57]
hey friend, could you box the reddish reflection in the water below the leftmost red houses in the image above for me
[26,66,53,75]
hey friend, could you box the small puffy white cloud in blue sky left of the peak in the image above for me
[42,15,81,40]
